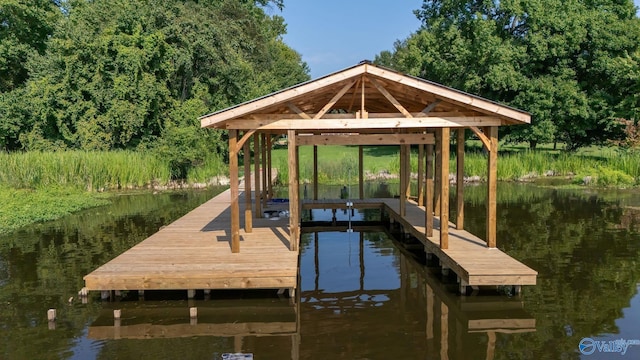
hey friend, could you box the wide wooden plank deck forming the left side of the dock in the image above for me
[84,190,298,291]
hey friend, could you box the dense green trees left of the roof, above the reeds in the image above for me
[0,0,308,177]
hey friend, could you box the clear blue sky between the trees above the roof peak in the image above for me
[273,0,640,79]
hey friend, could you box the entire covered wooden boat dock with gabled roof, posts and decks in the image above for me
[85,62,537,295]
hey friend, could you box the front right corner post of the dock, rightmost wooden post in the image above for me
[485,126,498,248]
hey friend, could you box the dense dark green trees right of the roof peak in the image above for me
[376,0,640,149]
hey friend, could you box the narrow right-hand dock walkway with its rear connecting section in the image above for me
[302,199,538,293]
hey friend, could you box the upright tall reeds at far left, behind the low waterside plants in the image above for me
[0,151,171,191]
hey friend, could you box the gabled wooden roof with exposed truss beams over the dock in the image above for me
[200,62,531,132]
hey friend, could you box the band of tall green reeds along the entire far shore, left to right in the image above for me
[0,147,640,191]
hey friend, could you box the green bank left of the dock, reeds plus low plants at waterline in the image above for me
[0,151,227,234]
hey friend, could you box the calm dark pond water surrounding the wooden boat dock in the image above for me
[0,184,640,359]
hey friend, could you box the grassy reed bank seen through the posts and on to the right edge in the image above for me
[273,146,640,187]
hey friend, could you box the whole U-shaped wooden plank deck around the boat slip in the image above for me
[84,190,537,291]
